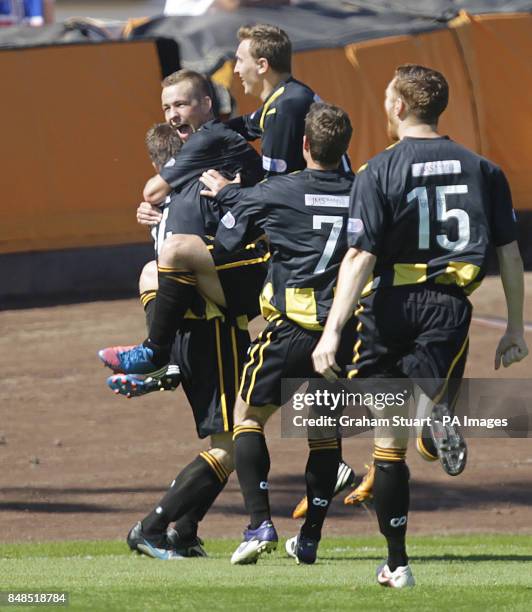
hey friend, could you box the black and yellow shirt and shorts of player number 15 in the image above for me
[348,137,517,402]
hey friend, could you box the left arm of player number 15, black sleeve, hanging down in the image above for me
[312,166,387,381]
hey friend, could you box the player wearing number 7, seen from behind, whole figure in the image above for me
[203,103,354,564]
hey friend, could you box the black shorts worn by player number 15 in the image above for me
[348,285,472,403]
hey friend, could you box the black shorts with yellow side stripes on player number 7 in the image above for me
[240,318,356,407]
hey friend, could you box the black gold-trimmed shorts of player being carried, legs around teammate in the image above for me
[211,239,270,319]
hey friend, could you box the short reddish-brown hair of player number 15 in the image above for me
[394,64,449,125]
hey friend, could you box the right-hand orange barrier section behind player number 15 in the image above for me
[228,13,532,210]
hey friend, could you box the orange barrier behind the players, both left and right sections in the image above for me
[0,13,532,254]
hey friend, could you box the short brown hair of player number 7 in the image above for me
[305,102,353,166]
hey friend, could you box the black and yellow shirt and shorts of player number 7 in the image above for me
[215,170,354,406]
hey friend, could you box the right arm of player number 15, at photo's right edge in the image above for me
[488,167,528,370]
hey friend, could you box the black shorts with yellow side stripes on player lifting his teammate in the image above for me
[172,319,250,438]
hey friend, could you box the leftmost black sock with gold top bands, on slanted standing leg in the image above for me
[142,452,229,534]
